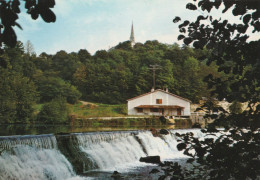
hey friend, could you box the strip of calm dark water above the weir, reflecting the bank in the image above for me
[0,123,191,136]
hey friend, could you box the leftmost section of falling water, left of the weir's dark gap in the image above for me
[0,135,86,180]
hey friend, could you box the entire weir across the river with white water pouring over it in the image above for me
[0,130,202,180]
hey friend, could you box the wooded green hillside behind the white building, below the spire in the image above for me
[0,41,223,122]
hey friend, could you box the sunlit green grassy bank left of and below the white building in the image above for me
[32,101,190,127]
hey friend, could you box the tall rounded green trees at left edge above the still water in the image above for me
[0,68,38,123]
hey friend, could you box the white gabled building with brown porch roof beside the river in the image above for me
[127,89,191,116]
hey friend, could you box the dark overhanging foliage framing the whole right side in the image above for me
[169,0,260,179]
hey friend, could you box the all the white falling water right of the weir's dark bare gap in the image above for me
[75,130,202,171]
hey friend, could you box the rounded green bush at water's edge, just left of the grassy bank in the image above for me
[37,97,69,123]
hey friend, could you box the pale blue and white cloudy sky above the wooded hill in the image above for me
[16,0,258,55]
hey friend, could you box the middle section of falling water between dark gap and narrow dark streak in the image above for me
[76,132,146,171]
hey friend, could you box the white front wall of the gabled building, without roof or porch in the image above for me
[127,91,190,116]
